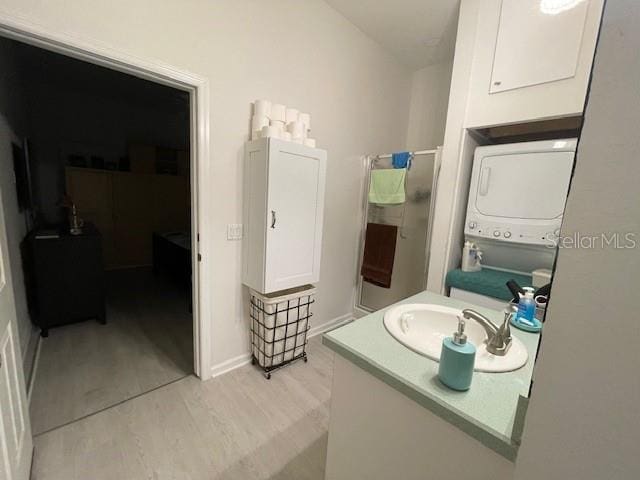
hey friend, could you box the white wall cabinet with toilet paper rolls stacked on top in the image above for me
[242,138,327,294]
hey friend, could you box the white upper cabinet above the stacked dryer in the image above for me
[465,0,603,128]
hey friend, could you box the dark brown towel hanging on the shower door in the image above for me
[360,223,398,288]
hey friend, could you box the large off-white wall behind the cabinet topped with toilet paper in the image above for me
[0,0,410,374]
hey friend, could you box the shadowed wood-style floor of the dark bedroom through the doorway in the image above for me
[30,268,193,436]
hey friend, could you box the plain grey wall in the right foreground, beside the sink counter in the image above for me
[516,0,640,480]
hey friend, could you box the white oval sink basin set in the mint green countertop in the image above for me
[384,303,529,372]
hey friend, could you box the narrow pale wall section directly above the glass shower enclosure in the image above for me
[407,61,453,150]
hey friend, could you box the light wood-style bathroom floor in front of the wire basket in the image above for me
[32,337,333,480]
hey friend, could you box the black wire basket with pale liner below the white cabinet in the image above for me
[250,285,316,379]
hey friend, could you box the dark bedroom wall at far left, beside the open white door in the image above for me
[0,38,33,357]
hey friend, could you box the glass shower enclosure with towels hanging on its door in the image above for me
[355,147,441,312]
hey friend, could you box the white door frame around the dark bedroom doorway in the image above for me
[0,12,212,380]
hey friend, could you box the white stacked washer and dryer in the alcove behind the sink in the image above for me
[451,138,577,306]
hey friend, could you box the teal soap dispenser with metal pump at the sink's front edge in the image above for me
[438,317,476,391]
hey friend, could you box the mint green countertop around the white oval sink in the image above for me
[322,292,539,461]
